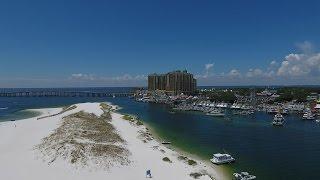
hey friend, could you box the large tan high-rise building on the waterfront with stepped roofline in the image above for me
[148,71,197,95]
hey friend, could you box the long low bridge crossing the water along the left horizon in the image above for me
[0,91,134,97]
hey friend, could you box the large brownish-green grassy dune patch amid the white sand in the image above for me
[35,111,130,168]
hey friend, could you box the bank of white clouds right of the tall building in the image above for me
[198,41,320,85]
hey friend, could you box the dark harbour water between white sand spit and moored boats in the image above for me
[113,96,320,180]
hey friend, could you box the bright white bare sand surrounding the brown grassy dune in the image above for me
[0,103,226,180]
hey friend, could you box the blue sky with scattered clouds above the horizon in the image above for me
[0,0,320,87]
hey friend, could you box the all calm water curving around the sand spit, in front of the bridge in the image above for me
[0,89,320,180]
